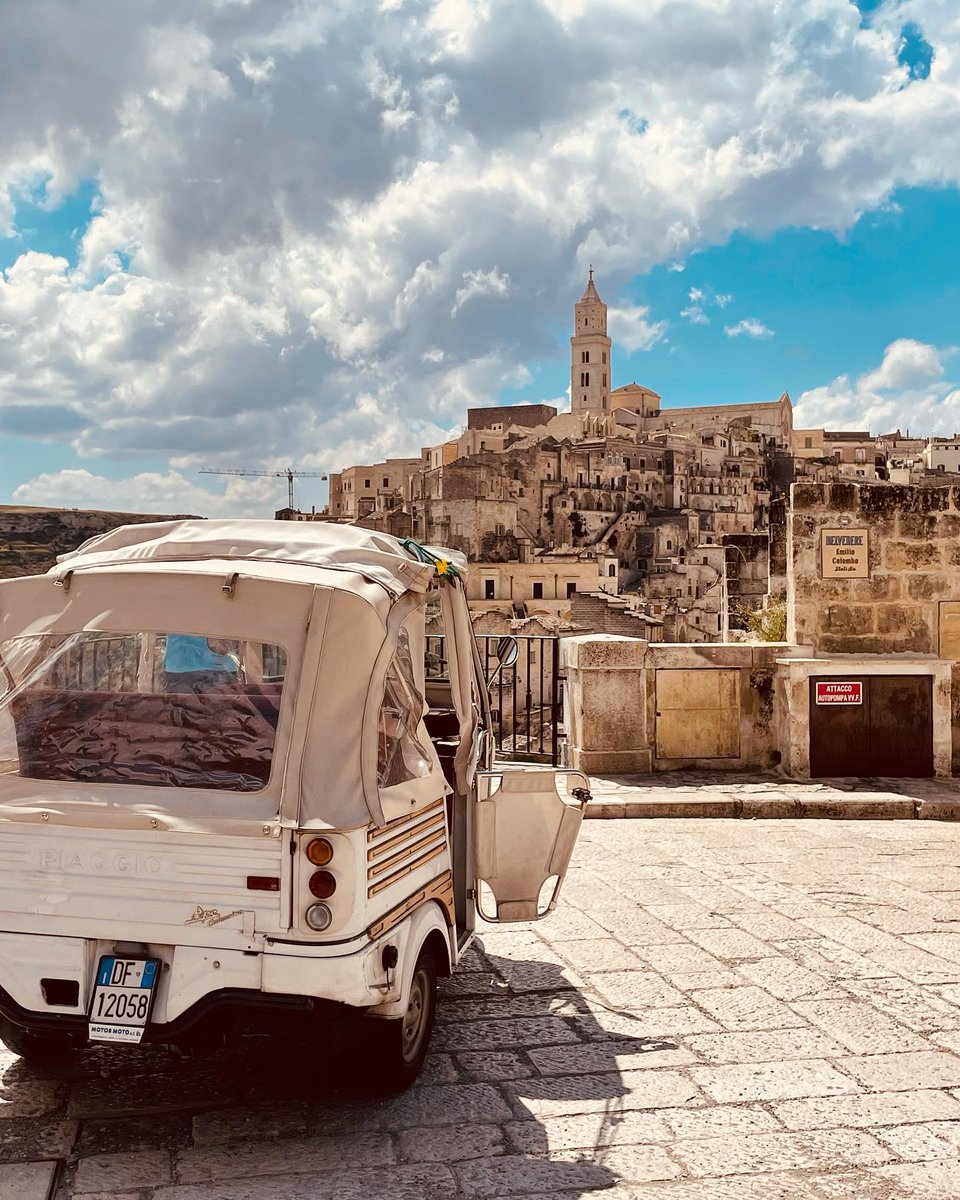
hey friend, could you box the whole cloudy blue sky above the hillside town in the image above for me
[0,0,960,515]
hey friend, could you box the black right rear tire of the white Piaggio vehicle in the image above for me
[365,946,437,1096]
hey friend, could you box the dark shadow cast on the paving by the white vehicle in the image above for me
[0,935,662,1200]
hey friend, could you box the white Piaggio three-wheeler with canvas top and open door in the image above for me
[0,521,586,1084]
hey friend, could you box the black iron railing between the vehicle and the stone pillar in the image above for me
[426,634,563,767]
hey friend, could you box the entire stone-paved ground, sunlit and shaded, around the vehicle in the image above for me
[0,820,960,1200]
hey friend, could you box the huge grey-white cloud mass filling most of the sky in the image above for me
[0,0,960,511]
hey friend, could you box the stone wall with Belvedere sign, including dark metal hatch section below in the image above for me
[782,482,960,775]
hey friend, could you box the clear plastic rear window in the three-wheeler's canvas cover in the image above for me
[0,630,287,792]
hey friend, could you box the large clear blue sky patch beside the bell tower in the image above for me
[494,188,960,432]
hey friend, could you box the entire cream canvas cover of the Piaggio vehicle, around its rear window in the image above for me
[0,521,474,836]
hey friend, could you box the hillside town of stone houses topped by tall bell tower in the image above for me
[285,270,960,642]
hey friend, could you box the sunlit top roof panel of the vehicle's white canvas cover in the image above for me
[48,520,467,595]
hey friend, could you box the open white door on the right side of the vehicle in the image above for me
[476,770,590,923]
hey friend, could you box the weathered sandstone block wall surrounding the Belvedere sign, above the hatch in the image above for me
[787,482,960,654]
